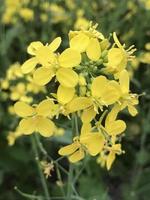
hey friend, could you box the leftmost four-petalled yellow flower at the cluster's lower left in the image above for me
[14,99,57,137]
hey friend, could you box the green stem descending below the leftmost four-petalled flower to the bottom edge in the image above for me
[31,135,51,200]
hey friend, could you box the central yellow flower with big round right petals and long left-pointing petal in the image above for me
[67,76,120,115]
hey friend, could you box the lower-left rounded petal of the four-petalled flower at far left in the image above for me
[19,118,36,135]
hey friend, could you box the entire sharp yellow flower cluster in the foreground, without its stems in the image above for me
[14,23,138,170]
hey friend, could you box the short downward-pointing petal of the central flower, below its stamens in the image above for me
[81,106,96,123]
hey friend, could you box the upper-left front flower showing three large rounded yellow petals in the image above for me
[33,48,81,88]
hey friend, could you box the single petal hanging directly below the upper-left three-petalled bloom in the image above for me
[57,85,75,104]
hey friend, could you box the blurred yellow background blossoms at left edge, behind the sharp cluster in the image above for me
[0,63,45,103]
